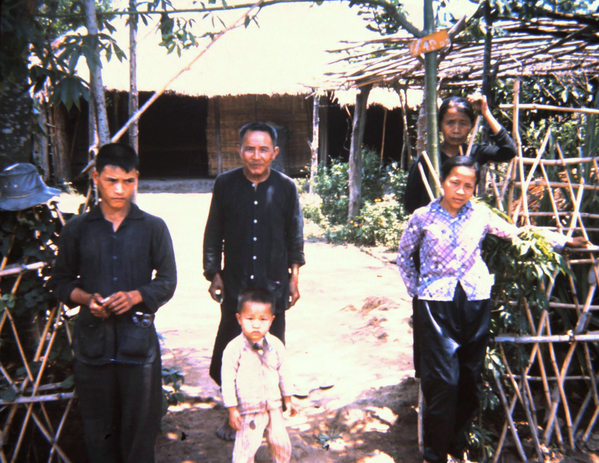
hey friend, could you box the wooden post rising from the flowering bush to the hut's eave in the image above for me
[348,85,372,218]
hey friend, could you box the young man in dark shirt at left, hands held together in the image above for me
[50,143,177,463]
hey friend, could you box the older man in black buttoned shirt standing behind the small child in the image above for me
[204,122,305,440]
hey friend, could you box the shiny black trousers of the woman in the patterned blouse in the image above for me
[418,284,491,463]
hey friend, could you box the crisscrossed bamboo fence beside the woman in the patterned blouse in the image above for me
[488,86,599,462]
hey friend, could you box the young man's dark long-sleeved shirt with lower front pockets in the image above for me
[50,204,177,364]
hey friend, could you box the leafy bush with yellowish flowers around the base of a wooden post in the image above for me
[303,149,406,249]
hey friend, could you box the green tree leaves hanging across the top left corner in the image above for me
[0,0,230,109]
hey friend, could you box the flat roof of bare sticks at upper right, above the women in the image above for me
[328,14,599,88]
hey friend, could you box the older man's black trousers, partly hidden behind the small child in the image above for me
[210,306,285,386]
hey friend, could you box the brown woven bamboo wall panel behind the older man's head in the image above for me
[206,95,312,176]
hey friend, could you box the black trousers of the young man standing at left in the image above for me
[75,355,162,463]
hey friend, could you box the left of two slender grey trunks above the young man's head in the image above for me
[83,0,110,146]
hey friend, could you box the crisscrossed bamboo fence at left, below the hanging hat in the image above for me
[0,211,75,463]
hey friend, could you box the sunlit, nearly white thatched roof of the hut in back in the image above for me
[90,2,390,105]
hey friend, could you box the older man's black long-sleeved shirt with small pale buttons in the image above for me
[204,168,305,313]
